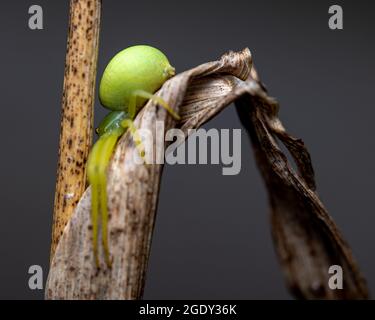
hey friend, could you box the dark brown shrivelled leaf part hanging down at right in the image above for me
[236,76,369,299]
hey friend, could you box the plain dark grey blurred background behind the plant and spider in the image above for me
[0,0,375,299]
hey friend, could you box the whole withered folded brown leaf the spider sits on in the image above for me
[46,49,367,299]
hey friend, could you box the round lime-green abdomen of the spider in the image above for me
[99,45,175,111]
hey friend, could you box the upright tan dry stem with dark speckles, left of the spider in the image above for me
[51,0,101,259]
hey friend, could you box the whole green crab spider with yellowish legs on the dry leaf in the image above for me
[87,45,180,267]
